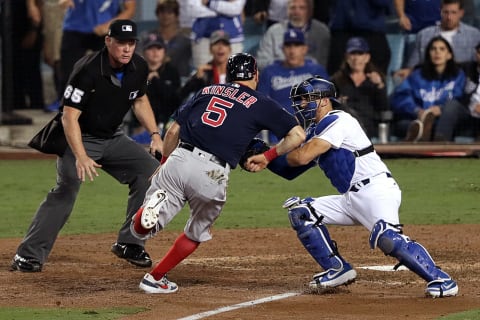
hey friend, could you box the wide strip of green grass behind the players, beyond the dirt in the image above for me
[0,159,480,237]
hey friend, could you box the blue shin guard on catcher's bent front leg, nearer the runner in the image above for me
[288,204,345,270]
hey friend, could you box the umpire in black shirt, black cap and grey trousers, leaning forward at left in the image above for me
[12,20,163,272]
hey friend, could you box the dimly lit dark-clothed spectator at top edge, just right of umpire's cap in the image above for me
[141,0,192,78]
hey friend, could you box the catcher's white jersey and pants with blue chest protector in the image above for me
[307,110,401,230]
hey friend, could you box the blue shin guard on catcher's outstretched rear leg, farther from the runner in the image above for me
[370,220,450,282]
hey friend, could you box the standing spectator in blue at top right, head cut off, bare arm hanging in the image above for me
[394,0,440,67]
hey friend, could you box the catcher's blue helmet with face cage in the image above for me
[290,76,339,127]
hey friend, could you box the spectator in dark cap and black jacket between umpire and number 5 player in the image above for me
[132,33,180,144]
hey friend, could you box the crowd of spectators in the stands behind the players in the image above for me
[3,0,480,143]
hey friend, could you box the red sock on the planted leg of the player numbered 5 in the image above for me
[152,229,200,280]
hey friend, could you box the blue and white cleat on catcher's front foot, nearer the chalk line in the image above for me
[309,263,357,289]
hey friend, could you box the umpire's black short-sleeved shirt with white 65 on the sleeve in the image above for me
[63,48,148,138]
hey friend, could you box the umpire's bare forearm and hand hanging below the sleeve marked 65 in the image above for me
[62,106,102,181]
